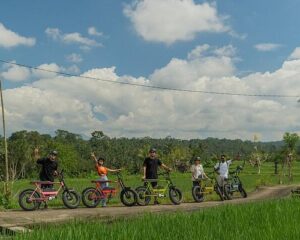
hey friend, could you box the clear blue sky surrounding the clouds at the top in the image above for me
[0,0,300,79]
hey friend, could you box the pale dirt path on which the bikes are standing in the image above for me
[0,185,293,231]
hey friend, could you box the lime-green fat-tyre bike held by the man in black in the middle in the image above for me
[135,172,183,206]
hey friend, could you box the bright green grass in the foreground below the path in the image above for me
[14,198,300,240]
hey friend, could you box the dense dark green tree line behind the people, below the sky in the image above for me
[0,130,300,180]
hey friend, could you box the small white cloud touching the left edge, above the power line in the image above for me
[0,23,36,48]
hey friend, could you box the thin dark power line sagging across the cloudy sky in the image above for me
[0,59,300,98]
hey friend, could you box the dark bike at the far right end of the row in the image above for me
[224,161,248,200]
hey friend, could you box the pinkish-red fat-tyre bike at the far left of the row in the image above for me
[19,170,80,211]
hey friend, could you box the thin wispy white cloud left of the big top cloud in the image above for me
[45,28,102,49]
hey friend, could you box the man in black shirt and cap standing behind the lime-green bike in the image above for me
[143,148,172,204]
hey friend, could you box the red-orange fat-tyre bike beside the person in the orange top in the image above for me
[82,172,137,208]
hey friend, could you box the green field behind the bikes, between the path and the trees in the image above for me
[2,162,300,209]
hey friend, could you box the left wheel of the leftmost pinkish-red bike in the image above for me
[19,189,41,211]
